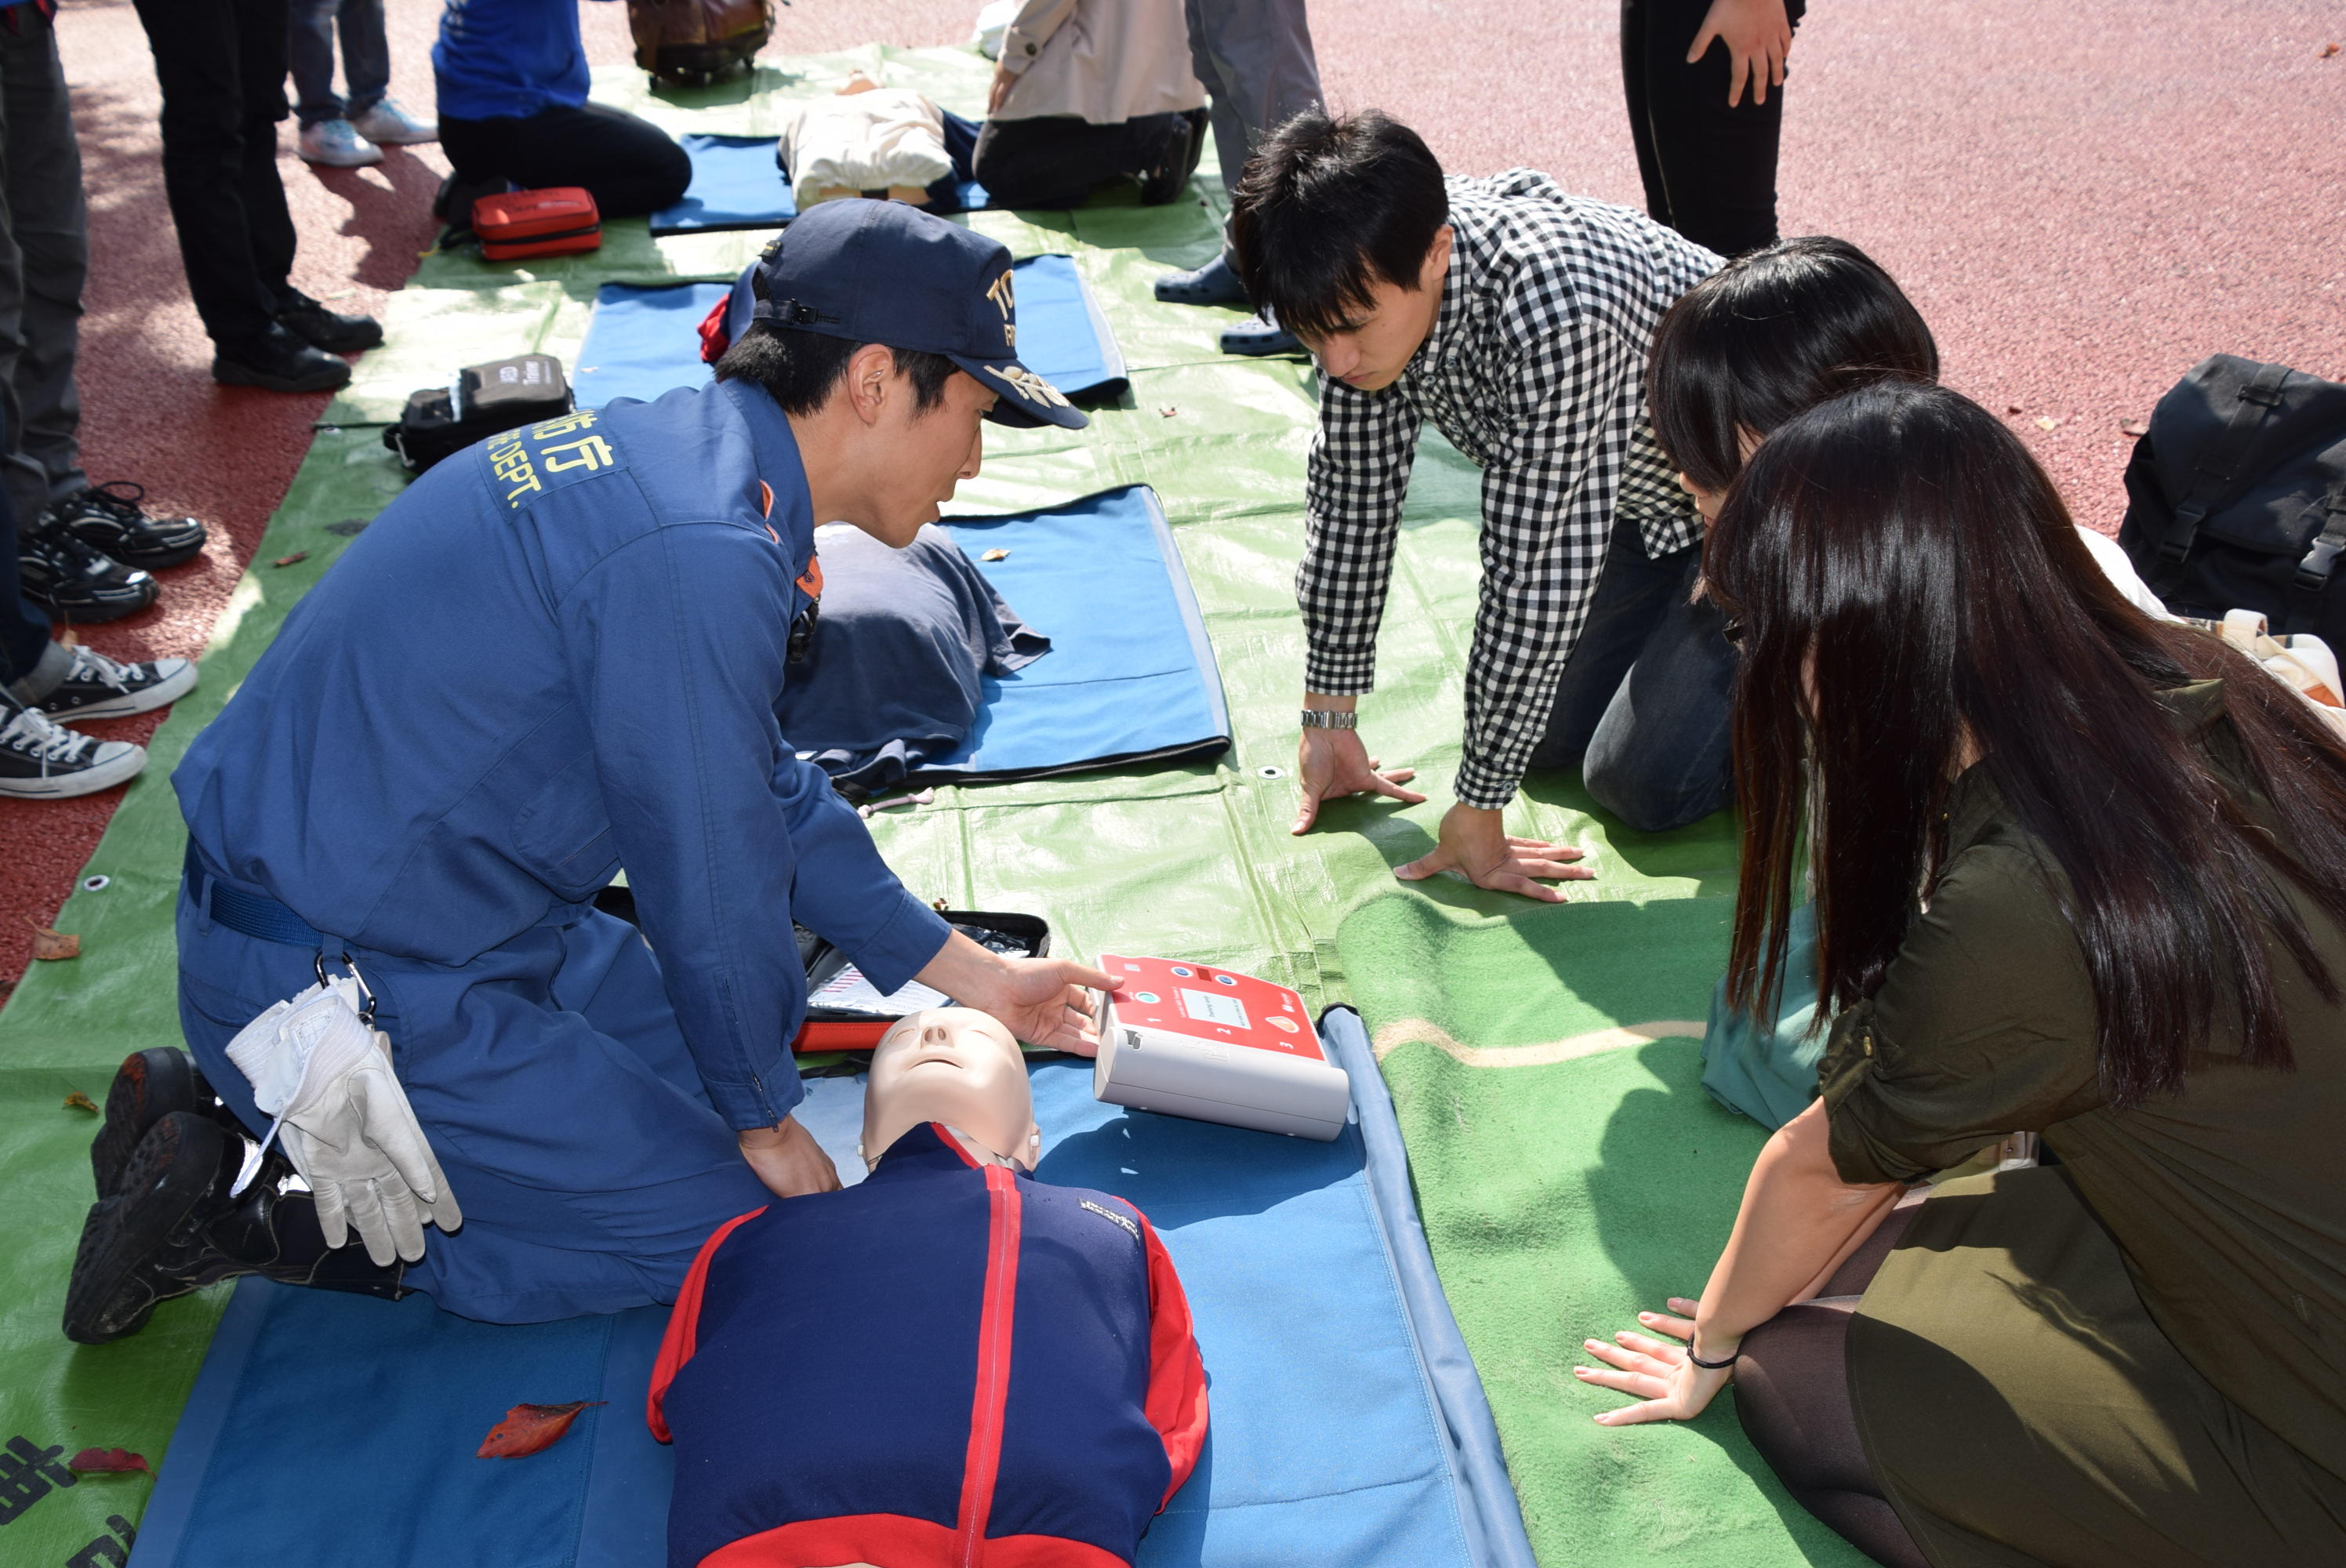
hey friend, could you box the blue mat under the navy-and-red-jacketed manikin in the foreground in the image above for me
[132,1009,1534,1568]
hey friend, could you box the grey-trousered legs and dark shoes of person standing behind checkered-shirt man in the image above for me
[1157,0,1320,354]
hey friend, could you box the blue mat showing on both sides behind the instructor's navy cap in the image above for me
[570,256,1126,408]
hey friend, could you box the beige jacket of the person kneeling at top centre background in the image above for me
[993,0,1206,125]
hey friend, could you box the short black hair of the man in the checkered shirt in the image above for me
[1229,108,1450,338]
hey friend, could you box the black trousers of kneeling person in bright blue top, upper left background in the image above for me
[441,103,692,218]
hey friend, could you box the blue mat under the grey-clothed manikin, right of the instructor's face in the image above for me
[913,484,1229,779]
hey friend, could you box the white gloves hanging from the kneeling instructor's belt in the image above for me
[227,953,464,1265]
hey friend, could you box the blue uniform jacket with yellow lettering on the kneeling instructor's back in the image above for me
[171,383,950,1129]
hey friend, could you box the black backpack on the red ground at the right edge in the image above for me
[2119,354,2346,648]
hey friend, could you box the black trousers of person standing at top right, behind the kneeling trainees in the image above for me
[1621,0,1807,256]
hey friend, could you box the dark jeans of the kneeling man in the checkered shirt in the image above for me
[1532,521,1736,833]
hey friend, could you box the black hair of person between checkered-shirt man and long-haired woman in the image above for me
[1647,234,1937,493]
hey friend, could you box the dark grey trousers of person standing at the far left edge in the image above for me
[0,5,89,528]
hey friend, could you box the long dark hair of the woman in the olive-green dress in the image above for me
[1703,380,2346,1110]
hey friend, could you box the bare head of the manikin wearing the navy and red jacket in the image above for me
[859,1007,1041,1171]
